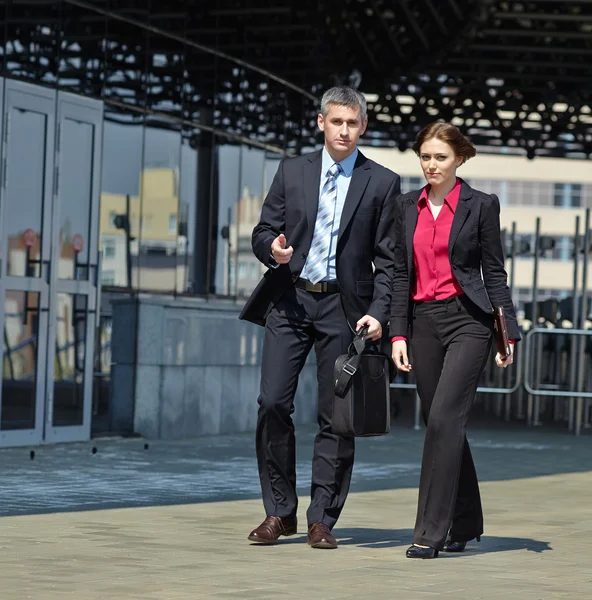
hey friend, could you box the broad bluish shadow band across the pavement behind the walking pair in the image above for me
[0,420,592,520]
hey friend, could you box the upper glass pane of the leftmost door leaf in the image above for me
[4,107,47,277]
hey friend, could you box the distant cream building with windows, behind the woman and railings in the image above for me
[362,146,592,309]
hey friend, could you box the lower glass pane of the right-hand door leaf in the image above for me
[52,294,88,427]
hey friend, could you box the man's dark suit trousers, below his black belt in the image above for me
[257,288,354,527]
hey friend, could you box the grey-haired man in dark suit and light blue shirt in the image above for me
[241,87,400,548]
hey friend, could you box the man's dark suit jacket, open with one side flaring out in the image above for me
[239,151,400,327]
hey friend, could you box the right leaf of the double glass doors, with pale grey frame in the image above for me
[45,92,103,442]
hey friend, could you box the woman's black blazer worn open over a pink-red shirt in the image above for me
[389,179,520,340]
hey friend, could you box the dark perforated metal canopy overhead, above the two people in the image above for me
[0,0,592,158]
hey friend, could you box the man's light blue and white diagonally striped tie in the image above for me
[306,163,341,283]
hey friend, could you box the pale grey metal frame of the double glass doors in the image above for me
[0,78,103,447]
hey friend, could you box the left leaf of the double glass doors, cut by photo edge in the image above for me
[0,80,55,446]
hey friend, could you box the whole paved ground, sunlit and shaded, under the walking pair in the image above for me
[0,423,592,600]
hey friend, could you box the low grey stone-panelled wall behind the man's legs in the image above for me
[111,296,317,439]
